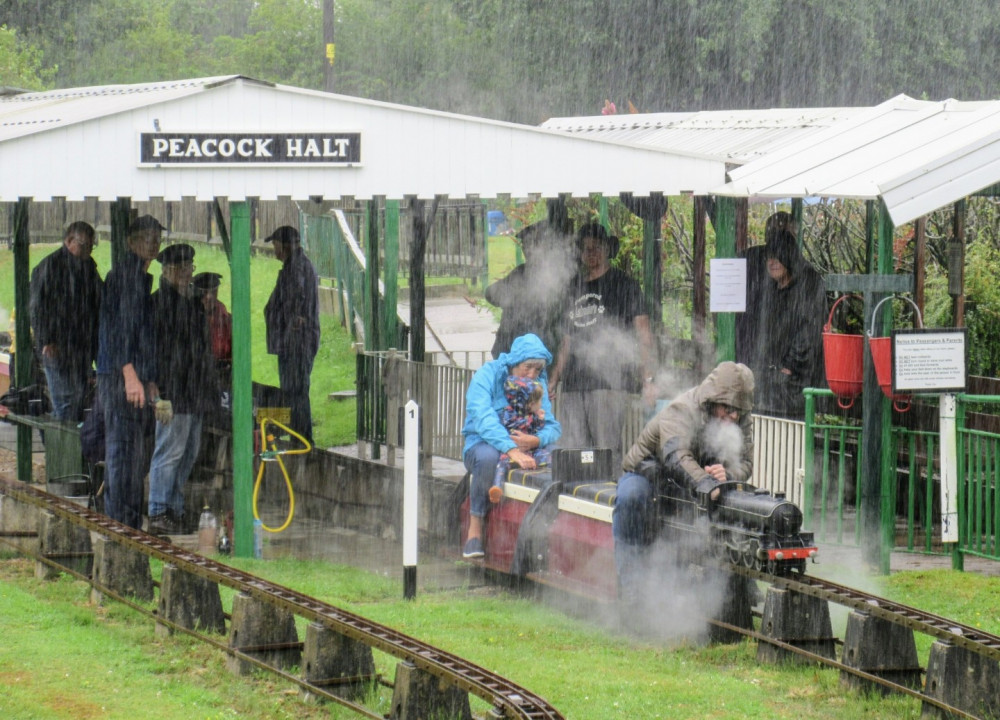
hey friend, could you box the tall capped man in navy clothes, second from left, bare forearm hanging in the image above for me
[97,215,163,530]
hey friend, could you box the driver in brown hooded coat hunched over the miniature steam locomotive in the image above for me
[612,361,754,602]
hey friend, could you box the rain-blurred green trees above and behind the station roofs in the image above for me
[7,0,1000,118]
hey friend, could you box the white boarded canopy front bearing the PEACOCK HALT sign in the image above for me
[0,75,726,202]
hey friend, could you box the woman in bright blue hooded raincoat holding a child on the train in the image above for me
[462,334,562,558]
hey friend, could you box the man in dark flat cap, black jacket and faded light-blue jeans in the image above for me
[148,243,219,535]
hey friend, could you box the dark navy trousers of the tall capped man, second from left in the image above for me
[97,373,153,530]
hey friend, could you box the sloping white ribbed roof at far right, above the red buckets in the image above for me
[713,95,1000,225]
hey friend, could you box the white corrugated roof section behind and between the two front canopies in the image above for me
[542,108,868,164]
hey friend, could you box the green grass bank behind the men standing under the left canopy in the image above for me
[0,243,356,447]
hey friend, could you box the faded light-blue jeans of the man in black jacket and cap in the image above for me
[149,415,201,519]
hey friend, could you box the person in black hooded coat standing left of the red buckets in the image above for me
[745,225,826,419]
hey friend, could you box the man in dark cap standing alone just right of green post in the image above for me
[264,225,319,443]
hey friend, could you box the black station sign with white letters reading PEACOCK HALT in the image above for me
[139,132,361,167]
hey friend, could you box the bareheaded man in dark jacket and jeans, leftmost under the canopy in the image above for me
[31,221,104,423]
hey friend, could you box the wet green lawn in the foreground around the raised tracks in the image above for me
[0,548,1000,720]
